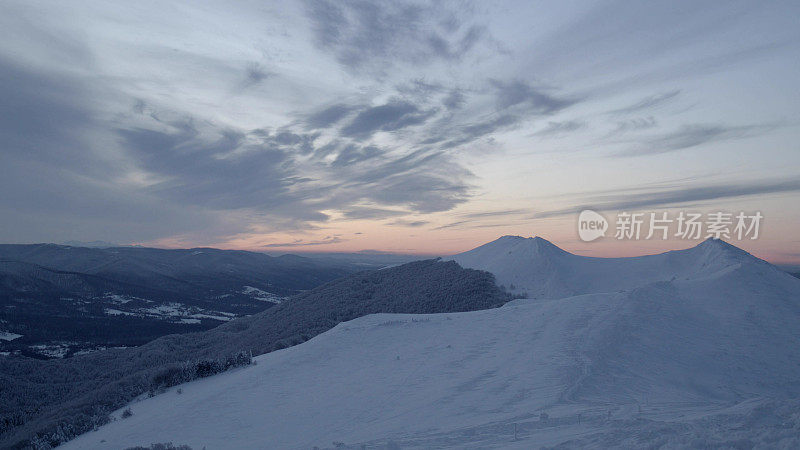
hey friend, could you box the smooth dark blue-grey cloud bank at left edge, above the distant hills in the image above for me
[0,56,239,246]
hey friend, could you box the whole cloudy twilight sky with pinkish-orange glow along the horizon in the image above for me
[0,0,800,264]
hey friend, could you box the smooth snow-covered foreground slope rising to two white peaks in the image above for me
[63,237,800,449]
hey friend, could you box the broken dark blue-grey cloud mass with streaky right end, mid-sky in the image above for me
[117,105,472,234]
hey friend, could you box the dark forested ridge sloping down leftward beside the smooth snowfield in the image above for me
[0,260,511,447]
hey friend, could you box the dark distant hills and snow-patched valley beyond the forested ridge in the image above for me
[0,244,356,357]
